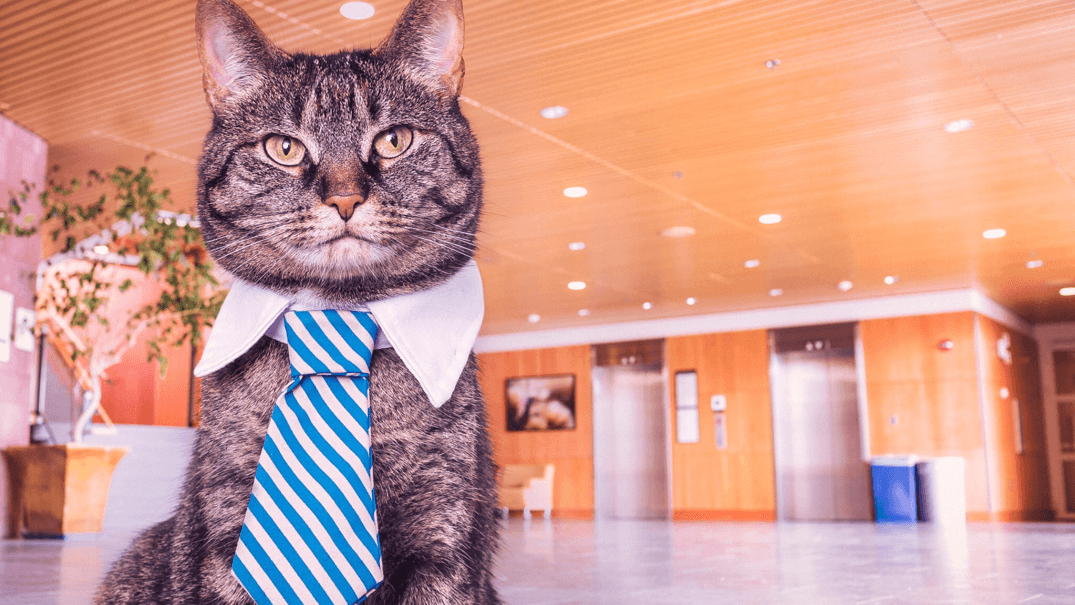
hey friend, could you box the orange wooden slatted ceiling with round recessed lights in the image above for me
[0,0,1075,333]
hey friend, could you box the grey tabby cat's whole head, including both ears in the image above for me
[198,0,482,301]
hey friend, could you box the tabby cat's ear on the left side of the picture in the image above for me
[195,0,285,110]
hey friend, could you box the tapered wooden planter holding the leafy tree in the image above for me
[3,444,128,537]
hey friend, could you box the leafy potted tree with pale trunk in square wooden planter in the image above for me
[0,165,225,535]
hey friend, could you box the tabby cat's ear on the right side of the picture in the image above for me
[376,0,464,97]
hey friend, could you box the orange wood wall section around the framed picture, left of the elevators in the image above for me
[478,346,593,518]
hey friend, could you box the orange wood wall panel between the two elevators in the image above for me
[665,330,776,519]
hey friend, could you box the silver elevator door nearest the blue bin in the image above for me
[773,348,870,521]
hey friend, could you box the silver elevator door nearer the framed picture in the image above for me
[592,365,670,519]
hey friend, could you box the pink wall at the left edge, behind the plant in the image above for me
[0,115,48,535]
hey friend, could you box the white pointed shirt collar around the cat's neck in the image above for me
[195,260,485,407]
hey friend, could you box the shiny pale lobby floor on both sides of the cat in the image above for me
[0,518,1075,605]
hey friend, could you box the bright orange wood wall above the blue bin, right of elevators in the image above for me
[859,312,989,518]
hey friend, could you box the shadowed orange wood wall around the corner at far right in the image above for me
[978,315,1052,520]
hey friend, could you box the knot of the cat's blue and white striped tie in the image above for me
[284,309,377,377]
